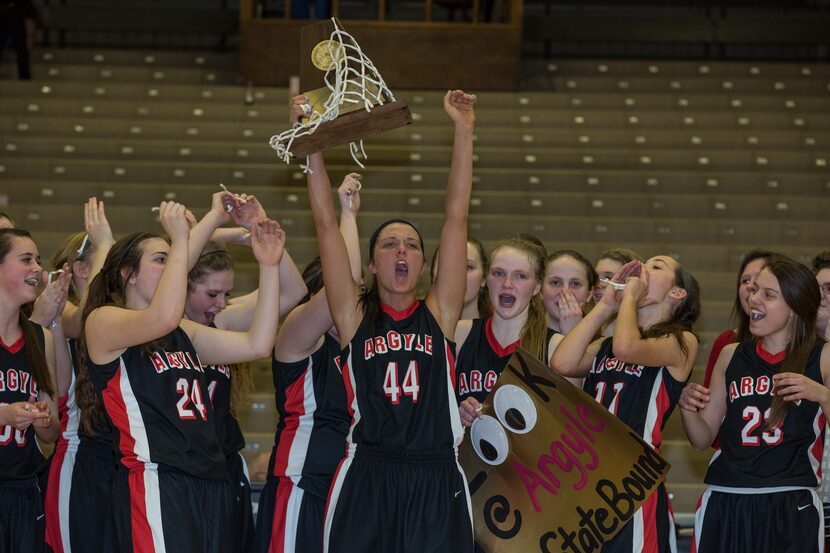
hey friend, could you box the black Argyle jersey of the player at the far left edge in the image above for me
[0,323,45,480]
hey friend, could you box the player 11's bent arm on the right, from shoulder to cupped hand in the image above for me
[606,271,698,382]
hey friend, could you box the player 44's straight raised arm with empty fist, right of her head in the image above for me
[426,90,476,336]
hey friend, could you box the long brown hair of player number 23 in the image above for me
[764,255,821,429]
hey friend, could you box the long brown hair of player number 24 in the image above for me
[75,232,161,436]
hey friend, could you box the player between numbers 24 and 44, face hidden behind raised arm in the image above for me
[256,173,361,553]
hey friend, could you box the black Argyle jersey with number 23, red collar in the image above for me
[704,340,824,488]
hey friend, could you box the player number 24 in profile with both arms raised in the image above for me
[77,202,284,553]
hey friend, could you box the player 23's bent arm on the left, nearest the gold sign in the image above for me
[679,344,738,451]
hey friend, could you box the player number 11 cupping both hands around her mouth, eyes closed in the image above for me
[551,255,700,553]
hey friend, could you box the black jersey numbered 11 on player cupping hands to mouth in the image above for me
[582,338,685,449]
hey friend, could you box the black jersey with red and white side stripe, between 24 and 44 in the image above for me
[268,334,351,498]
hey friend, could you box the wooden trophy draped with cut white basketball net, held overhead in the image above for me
[269,18,412,172]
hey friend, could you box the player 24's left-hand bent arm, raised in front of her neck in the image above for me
[85,202,190,364]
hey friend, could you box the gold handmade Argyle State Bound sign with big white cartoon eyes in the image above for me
[459,348,669,553]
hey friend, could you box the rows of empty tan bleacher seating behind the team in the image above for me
[0,49,830,513]
